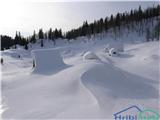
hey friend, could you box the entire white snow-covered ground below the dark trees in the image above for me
[1,33,160,119]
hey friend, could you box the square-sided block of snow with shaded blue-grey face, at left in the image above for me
[31,49,66,73]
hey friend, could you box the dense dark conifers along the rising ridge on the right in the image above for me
[65,5,160,39]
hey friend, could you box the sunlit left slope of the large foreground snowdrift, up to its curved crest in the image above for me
[2,61,104,119]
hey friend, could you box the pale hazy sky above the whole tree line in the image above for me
[0,1,158,37]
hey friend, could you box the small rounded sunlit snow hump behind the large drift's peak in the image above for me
[83,51,99,60]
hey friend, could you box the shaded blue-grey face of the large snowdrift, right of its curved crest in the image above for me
[82,62,158,100]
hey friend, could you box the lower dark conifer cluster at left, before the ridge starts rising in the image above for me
[0,28,64,50]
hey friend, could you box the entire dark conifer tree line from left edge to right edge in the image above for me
[1,5,160,50]
